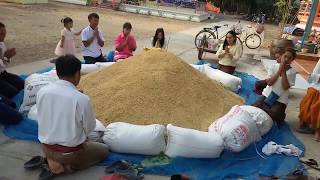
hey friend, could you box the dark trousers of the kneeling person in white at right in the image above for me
[252,96,287,125]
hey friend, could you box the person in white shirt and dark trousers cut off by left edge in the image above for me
[0,22,24,98]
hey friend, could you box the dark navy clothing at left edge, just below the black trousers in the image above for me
[0,94,22,125]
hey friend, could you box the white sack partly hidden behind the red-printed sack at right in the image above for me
[240,105,273,136]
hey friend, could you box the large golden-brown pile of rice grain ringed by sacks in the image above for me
[79,51,243,131]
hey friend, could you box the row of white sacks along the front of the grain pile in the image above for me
[29,105,273,158]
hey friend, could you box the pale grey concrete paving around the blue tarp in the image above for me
[0,21,320,180]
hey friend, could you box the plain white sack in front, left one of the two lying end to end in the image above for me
[103,122,166,155]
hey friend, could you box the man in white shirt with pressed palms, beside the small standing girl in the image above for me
[81,13,106,64]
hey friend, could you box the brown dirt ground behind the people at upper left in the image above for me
[0,1,199,66]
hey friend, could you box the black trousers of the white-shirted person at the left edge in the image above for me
[0,71,24,98]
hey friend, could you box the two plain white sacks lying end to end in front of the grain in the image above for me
[103,122,224,158]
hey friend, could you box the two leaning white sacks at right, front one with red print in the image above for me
[209,105,272,152]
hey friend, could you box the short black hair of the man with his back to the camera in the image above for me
[55,55,81,77]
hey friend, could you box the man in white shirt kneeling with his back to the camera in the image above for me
[37,55,108,180]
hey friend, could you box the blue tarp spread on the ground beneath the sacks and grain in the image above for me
[4,64,304,179]
